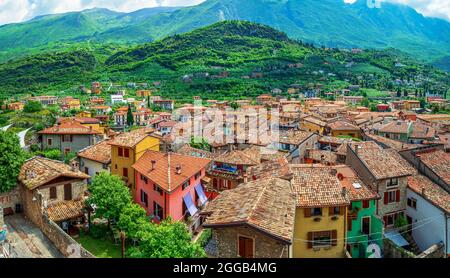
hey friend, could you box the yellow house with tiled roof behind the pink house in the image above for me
[109,128,160,192]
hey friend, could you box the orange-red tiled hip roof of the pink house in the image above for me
[133,151,211,192]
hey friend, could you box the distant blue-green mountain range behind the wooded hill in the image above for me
[0,0,450,68]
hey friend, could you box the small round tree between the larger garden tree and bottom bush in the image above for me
[117,204,149,239]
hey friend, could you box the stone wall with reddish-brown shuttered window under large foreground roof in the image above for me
[213,226,291,258]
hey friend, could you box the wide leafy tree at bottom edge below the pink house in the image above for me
[127,219,206,258]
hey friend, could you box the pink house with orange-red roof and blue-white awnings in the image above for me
[133,150,211,222]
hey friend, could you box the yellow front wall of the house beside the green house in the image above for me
[293,207,347,258]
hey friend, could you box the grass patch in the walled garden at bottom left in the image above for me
[75,235,122,258]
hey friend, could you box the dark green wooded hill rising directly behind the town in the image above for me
[0,21,450,101]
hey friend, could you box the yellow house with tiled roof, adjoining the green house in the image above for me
[291,165,350,258]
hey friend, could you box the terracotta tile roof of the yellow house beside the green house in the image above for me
[290,165,350,208]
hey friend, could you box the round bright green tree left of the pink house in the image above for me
[87,172,131,223]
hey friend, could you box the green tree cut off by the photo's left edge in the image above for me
[0,131,26,193]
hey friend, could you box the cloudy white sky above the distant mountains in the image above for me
[0,0,450,25]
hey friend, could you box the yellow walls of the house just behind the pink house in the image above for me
[111,136,160,192]
